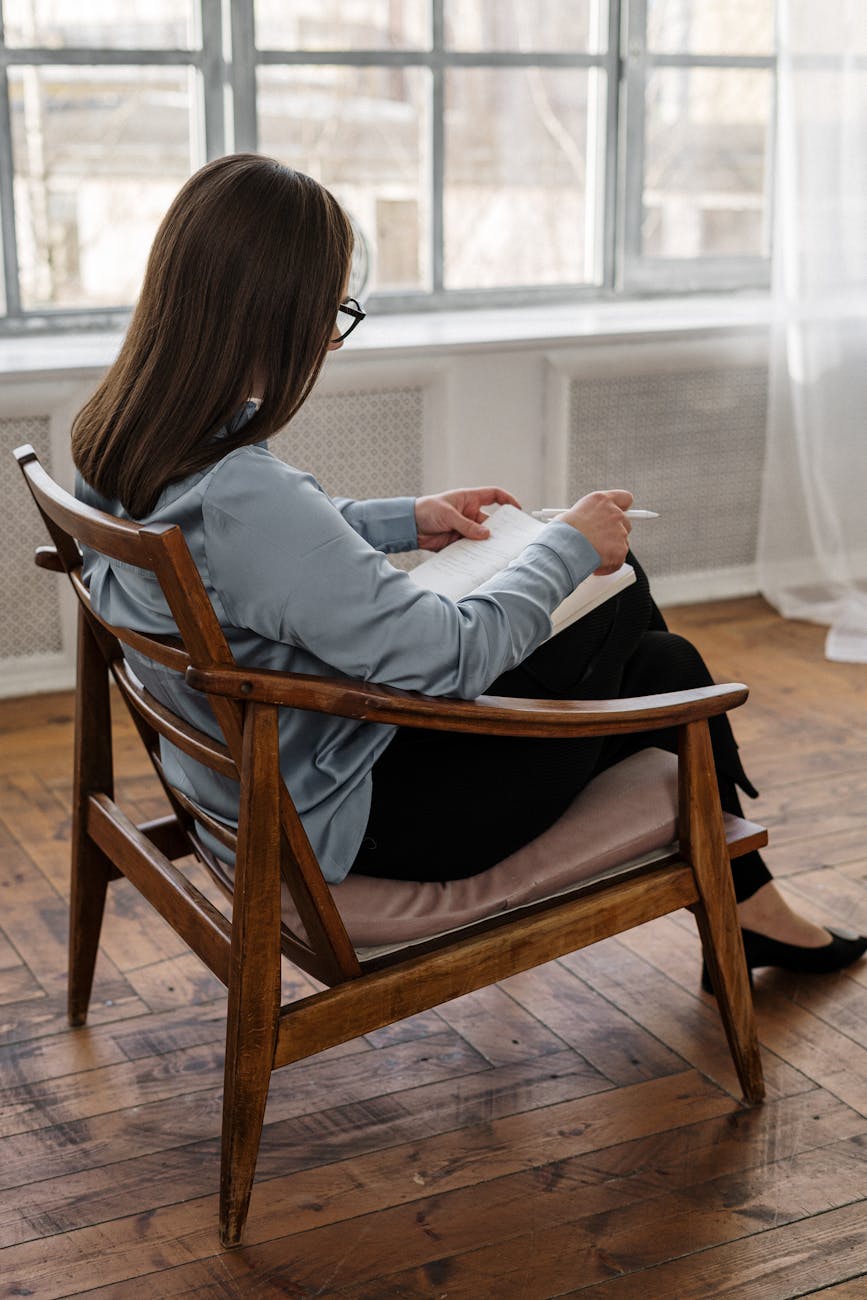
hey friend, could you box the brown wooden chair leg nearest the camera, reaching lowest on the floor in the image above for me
[220,705,281,1245]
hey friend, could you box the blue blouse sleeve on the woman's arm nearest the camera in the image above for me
[203,447,599,698]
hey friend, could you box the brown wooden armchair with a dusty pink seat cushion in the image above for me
[16,447,767,1245]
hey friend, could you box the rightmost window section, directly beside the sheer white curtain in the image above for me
[621,0,775,289]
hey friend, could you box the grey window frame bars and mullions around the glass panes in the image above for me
[0,0,776,337]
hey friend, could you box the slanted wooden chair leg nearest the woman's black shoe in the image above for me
[680,722,764,1102]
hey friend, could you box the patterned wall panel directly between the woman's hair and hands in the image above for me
[270,389,424,568]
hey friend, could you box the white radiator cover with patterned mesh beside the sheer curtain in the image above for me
[546,334,767,603]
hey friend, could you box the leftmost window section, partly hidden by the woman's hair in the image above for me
[0,0,222,328]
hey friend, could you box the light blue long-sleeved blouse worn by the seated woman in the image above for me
[75,426,599,883]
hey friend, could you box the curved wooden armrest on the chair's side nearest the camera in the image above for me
[186,667,749,737]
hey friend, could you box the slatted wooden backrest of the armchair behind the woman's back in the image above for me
[16,446,360,983]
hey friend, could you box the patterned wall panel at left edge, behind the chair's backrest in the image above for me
[0,416,62,660]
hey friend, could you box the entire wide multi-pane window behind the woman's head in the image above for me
[0,0,775,333]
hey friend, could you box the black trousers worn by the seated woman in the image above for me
[352,555,771,901]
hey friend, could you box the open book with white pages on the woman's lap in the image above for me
[409,506,636,636]
